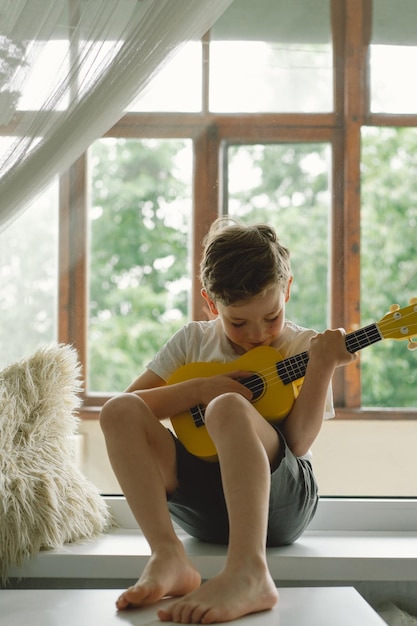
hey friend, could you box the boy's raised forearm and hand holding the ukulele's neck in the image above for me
[282,329,356,456]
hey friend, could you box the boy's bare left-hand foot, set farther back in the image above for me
[116,548,201,611]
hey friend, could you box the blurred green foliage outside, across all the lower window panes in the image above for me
[0,128,417,407]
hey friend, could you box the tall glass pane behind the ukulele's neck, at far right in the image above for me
[361,128,417,407]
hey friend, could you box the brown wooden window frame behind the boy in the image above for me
[59,0,417,420]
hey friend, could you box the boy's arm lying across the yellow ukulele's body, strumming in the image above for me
[126,370,252,420]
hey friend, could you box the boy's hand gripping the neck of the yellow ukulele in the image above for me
[309,328,357,369]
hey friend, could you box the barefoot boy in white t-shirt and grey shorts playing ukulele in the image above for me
[101,218,355,624]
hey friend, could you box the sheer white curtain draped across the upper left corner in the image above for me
[0,0,232,229]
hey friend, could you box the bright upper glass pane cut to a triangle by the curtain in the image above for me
[128,41,202,113]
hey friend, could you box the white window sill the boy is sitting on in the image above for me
[5,498,417,584]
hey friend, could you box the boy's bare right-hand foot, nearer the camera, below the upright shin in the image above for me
[158,567,278,624]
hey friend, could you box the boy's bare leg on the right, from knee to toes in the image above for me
[158,394,280,623]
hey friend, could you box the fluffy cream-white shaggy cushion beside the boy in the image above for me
[0,344,110,582]
